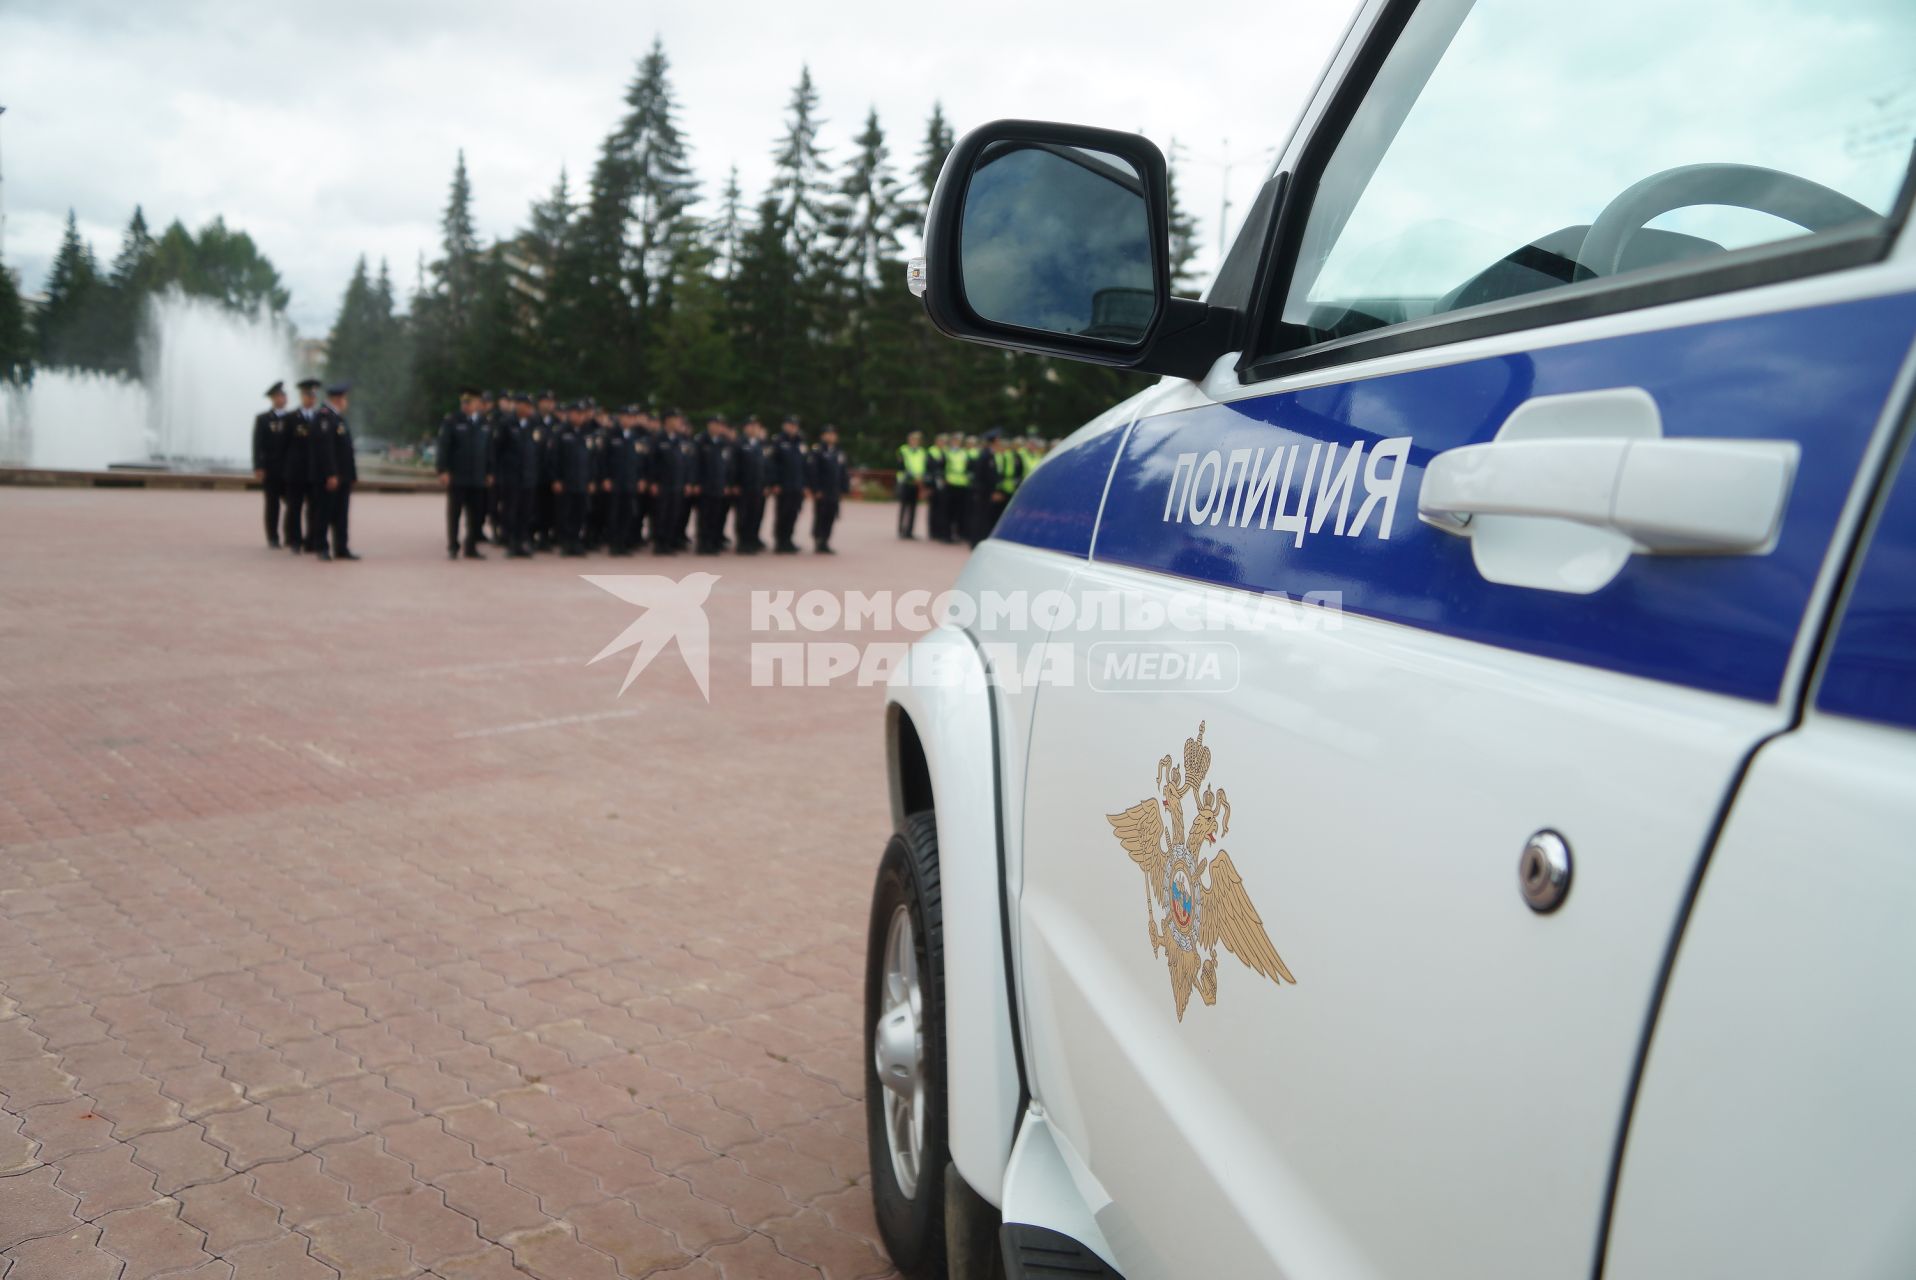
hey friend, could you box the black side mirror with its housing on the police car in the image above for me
[908,121,1234,377]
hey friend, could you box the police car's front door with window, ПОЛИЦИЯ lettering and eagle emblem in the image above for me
[1006,0,1916,1280]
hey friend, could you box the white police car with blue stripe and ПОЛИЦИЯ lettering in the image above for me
[866,0,1916,1280]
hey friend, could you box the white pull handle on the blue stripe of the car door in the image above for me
[1418,437,1799,556]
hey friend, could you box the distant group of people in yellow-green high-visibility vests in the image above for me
[897,427,1050,546]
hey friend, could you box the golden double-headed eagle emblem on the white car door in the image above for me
[1106,720,1297,1021]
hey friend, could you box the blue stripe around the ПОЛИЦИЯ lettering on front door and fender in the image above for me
[996,293,1916,701]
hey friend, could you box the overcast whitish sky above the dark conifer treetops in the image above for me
[0,0,1353,335]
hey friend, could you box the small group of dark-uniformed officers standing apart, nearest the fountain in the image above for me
[253,377,358,561]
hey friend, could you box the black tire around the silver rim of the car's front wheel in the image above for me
[864,811,950,1280]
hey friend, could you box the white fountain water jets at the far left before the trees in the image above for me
[0,289,295,471]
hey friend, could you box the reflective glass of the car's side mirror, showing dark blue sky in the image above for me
[958,142,1157,343]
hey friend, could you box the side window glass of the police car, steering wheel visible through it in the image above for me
[1282,0,1916,347]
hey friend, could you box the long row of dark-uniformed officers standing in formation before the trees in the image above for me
[435,389,851,560]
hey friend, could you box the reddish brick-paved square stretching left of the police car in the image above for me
[0,489,964,1280]
